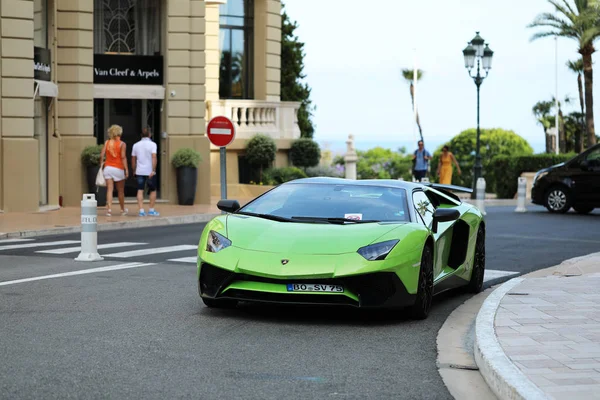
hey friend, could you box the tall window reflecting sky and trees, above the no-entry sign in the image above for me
[219,0,254,99]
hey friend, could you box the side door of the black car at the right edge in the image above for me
[571,146,600,207]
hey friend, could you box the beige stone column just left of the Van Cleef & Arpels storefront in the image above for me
[55,0,96,207]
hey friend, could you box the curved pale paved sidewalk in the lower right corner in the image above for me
[475,253,600,400]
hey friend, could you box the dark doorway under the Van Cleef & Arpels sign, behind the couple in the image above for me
[94,99,161,198]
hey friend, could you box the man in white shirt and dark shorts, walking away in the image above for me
[131,127,160,217]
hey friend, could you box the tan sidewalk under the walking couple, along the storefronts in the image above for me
[0,198,249,239]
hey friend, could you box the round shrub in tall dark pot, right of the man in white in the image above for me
[171,148,202,206]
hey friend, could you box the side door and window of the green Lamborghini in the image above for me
[413,190,452,280]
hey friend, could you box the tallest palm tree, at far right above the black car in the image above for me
[528,0,600,147]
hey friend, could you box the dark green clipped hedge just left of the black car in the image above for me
[486,153,576,199]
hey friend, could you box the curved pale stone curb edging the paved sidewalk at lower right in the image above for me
[474,277,547,400]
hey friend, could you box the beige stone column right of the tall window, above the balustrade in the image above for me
[254,0,282,101]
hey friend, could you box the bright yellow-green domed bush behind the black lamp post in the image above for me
[430,128,533,193]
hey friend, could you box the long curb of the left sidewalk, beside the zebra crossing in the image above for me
[0,214,221,239]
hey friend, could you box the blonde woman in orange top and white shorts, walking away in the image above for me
[100,125,129,217]
